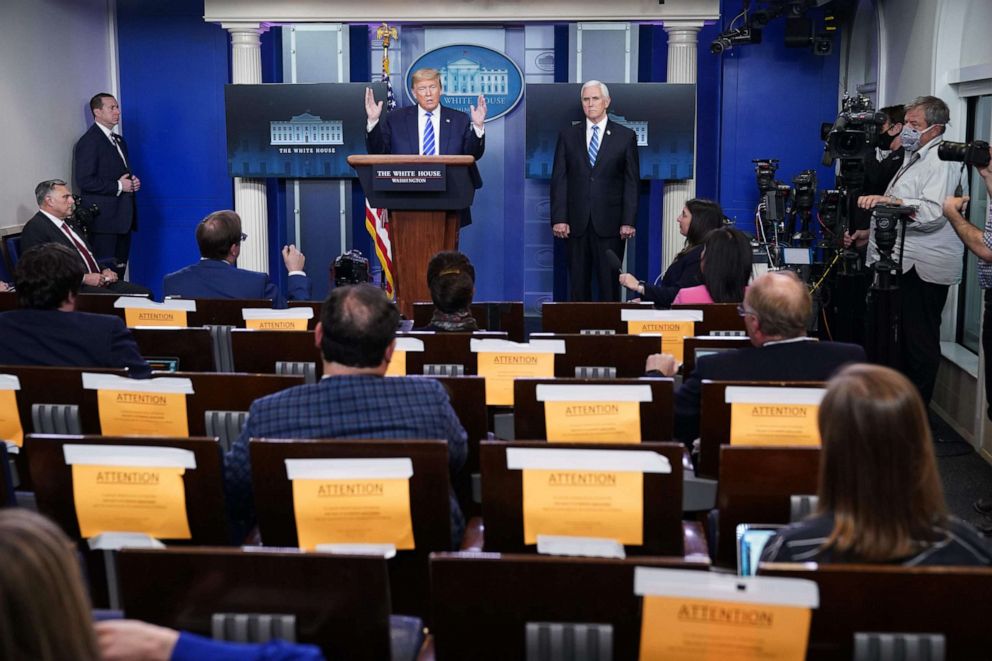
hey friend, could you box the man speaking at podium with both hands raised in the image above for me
[365,69,486,227]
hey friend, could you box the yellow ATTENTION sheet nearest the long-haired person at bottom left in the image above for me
[72,464,191,539]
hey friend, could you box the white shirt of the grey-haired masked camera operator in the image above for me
[866,138,964,285]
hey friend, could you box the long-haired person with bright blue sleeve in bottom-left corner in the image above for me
[0,508,324,661]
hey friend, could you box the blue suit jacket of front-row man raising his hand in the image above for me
[162,259,310,308]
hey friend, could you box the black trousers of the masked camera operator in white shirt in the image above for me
[899,266,950,405]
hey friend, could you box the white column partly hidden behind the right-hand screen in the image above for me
[661,21,703,271]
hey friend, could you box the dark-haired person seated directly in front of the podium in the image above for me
[424,250,479,331]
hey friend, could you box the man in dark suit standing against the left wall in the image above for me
[73,92,141,276]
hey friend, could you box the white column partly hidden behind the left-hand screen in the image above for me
[221,23,269,273]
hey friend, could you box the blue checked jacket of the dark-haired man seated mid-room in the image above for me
[224,376,468,548]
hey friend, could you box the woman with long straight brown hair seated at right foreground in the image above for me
[761,365,992,566]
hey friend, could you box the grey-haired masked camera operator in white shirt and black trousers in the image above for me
[858,96,963,405]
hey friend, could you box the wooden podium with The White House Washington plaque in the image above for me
[348,154,475,319]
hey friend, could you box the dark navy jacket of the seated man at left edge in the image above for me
[0,308,151,378]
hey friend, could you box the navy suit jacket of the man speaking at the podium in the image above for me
[365,105,486,227]
